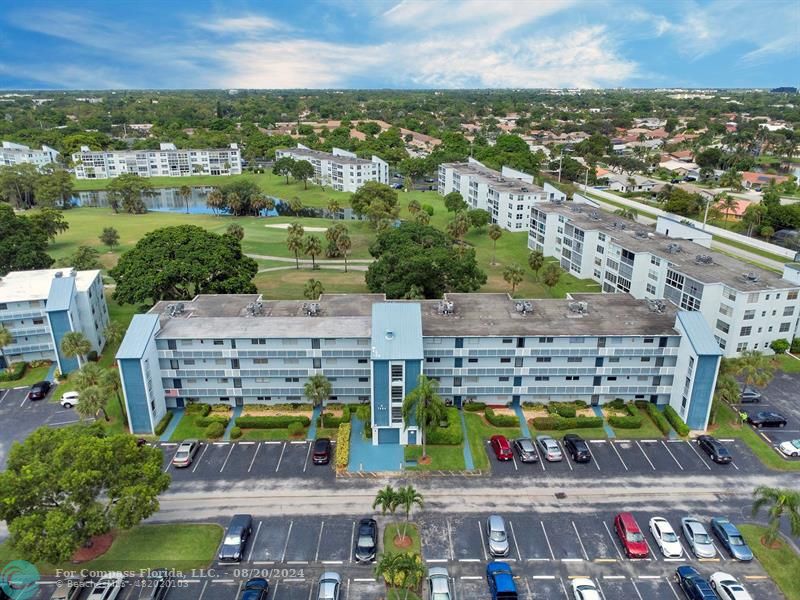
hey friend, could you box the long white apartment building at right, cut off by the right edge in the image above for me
[528,202,800,357]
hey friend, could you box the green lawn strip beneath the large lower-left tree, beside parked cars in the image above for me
[0,523,222,574]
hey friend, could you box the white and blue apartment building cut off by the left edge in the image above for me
[0,268,108,373]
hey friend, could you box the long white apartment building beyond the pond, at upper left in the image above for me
[72,144,242,179]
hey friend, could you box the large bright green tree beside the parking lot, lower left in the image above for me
[0,426,170,564]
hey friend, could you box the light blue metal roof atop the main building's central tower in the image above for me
[372,302,422,360]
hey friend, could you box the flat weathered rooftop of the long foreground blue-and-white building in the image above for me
[150,294,676,339]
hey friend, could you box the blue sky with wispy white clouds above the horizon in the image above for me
[0,0,800,89]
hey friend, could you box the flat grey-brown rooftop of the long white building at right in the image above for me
[534,202,798,293]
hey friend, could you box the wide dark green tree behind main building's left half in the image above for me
[109,225,258,304]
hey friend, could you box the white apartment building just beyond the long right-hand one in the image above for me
[438,158,566,231]
